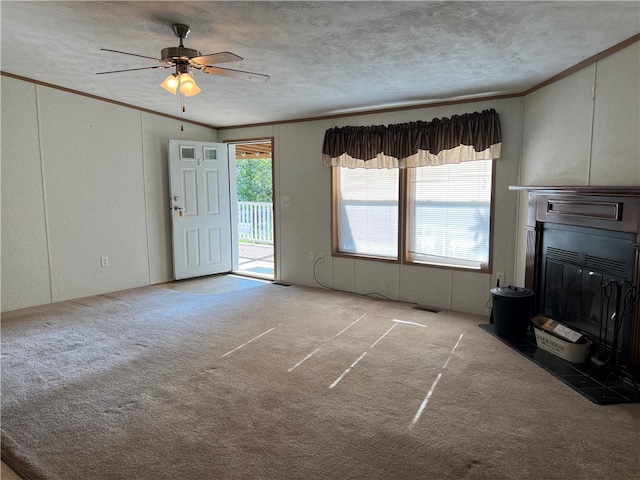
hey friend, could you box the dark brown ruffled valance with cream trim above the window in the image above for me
[322,109,502,168]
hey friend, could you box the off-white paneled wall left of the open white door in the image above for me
[1,77,217,311]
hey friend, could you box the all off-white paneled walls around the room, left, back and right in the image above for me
[1,38,640,314]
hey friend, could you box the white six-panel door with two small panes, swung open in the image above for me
[169,140,235,280]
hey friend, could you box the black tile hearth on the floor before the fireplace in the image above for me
[478,324,640,405]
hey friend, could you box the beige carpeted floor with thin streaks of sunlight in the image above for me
[2,284,640,480]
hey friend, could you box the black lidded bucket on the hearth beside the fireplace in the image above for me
[491,285,533,338]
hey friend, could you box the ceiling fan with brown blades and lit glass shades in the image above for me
[97,23,270,97]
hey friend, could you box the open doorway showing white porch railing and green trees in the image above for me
[227,139,276,280]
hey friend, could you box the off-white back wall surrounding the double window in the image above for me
[218,99,523,315]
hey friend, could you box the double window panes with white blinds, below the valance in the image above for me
[333,160,493,271]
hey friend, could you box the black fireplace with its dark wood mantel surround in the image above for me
[510,187,640,379]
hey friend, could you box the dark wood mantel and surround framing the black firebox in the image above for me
[509,186,640,378]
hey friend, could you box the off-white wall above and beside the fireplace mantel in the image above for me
[516,42,640,282]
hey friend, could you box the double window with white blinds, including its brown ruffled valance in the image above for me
[322,109,502,272]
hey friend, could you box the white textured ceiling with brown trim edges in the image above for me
[0,0,640,127]
